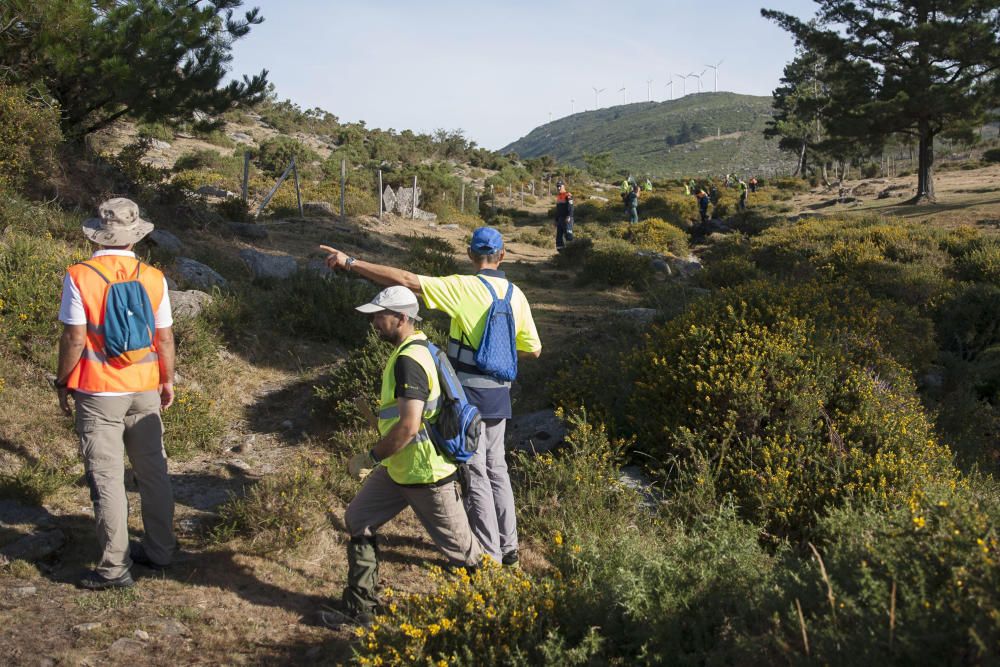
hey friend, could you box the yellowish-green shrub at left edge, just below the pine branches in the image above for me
[0,83,62,186]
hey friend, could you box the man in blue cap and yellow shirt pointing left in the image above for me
[320,227,542,565]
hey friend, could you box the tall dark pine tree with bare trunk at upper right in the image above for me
[761,0,1000,202]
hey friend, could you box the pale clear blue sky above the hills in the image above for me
[232,0,816,149]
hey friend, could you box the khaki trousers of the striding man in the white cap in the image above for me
[344,466,483,613]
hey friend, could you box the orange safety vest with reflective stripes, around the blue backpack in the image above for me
[66,255,163,394]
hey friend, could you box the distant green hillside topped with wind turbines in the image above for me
[500,93,794,177]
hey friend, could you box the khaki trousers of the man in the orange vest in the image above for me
[73,391,176,579]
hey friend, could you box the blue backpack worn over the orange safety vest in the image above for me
[83,262,156,367]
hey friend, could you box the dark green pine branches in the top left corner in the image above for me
[0,0,267,137]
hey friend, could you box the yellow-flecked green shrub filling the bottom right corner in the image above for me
[785,479,1000,664]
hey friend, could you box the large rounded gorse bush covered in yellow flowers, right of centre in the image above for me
[628,292,953,534]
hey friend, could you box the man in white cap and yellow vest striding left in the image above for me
[320,286,483,626]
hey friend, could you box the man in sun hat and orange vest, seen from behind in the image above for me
[55,198,176,590]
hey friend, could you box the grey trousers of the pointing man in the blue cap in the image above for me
[465,419,517,563]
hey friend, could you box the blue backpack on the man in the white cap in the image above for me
[410,340,482,464]
